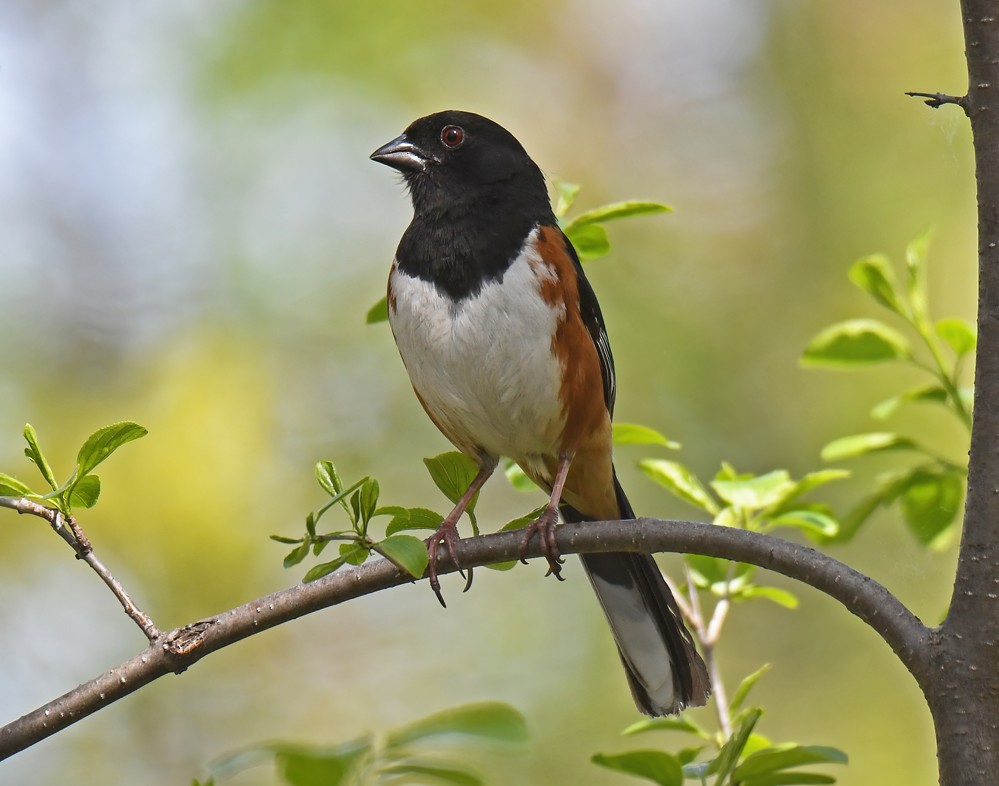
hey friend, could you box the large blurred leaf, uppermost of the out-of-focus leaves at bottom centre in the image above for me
[385,701,529,750]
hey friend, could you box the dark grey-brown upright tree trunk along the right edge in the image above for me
[932,0,999,786]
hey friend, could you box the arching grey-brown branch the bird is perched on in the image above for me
[0,519,930,760]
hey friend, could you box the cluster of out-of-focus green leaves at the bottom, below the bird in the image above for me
[194,702,528,786]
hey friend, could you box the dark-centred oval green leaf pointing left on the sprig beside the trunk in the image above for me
[801,319,912,368]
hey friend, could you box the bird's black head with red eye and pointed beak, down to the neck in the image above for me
[371,110,551,213]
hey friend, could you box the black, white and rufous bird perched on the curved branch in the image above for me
[371,111,710,716]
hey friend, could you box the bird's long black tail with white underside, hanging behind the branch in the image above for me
[562,475,711,716]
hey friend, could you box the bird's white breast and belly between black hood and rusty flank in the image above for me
[389,255,564,465]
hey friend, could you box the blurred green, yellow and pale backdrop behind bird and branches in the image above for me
[0,0,975,786]
